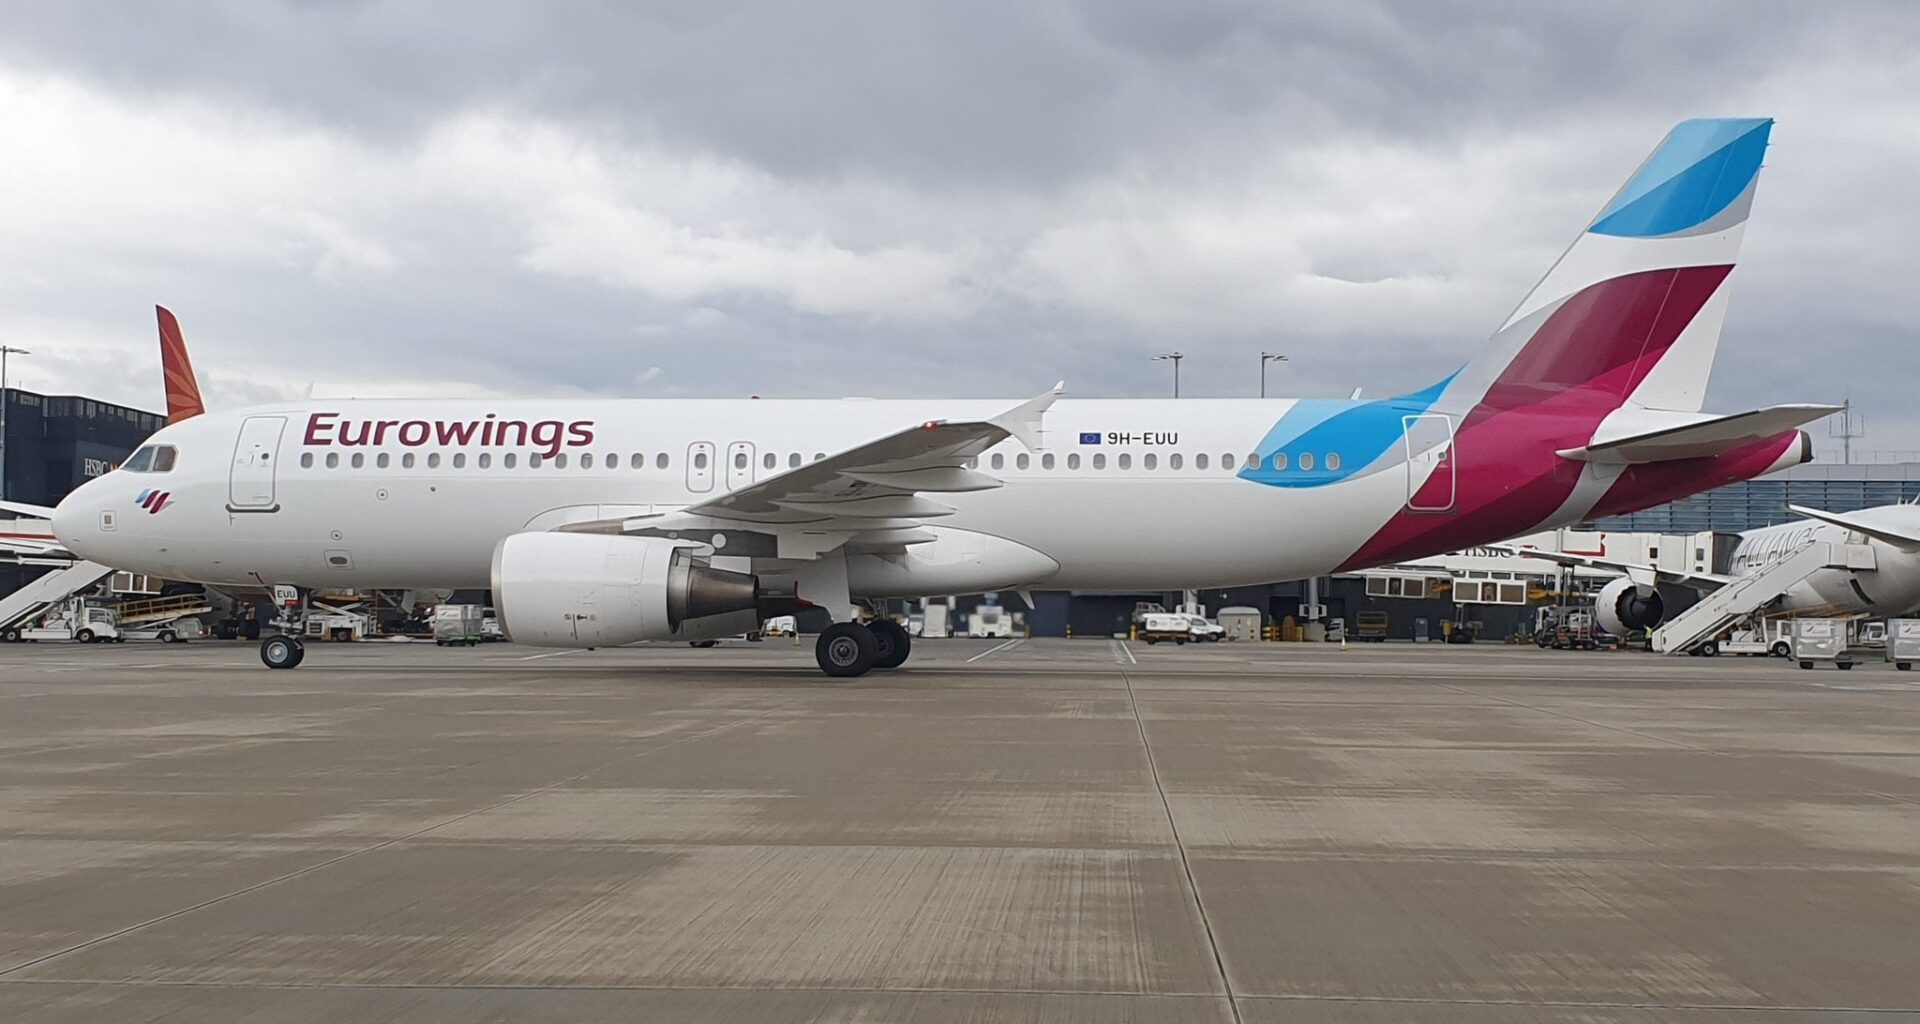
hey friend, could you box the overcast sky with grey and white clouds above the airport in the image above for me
[0,0,1920,450]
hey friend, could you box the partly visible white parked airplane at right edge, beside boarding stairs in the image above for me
[1509,503,1920,657]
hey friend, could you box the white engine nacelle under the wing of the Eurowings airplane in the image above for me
[493,532,760,647]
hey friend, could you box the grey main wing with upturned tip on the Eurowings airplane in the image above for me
[561,382,1066,559]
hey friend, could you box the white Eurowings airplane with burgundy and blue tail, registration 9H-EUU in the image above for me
[30,117,1836,676]
